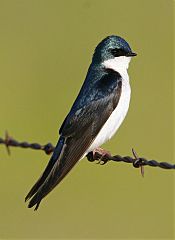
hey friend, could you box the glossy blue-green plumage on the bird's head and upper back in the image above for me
[60,35,132,126]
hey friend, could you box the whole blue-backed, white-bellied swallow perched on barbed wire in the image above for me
[25,35,137,210]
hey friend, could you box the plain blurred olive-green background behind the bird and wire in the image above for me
[0,0,175,239]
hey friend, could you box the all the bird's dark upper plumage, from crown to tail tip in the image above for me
[26,36,132,209]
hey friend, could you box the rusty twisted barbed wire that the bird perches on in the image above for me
[0,131,175,171]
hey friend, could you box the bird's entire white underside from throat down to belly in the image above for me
[82,56,131,158]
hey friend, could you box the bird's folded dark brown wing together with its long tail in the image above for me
[26,70,122,209]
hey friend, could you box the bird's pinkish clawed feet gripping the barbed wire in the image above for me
[87,148,111,165]
